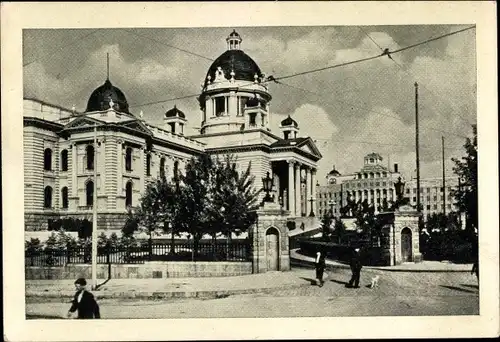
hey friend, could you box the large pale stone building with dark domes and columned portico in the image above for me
[23,31,321,231]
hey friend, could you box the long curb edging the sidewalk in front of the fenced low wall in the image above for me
[25,284,310,299]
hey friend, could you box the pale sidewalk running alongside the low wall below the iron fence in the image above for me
[26,270,320,299]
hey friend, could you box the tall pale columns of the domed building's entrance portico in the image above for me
[288,160,316,216]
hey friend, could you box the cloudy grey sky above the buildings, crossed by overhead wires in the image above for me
[23,25,477,184]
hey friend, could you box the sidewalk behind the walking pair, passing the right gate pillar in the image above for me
[290,249,472,272]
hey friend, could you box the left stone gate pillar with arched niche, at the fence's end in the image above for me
[251,202,290,273]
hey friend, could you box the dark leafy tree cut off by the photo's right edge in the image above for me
[452,125,479,234]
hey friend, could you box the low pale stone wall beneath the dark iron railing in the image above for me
[25,261,252,280]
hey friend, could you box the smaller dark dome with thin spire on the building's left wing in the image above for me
[86,79,129,113]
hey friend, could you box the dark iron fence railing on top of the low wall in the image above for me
[25,240,252,266]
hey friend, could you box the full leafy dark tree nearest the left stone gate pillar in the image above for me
[173,154,259,259]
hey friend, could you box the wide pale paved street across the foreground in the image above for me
[26,269,479,318]
